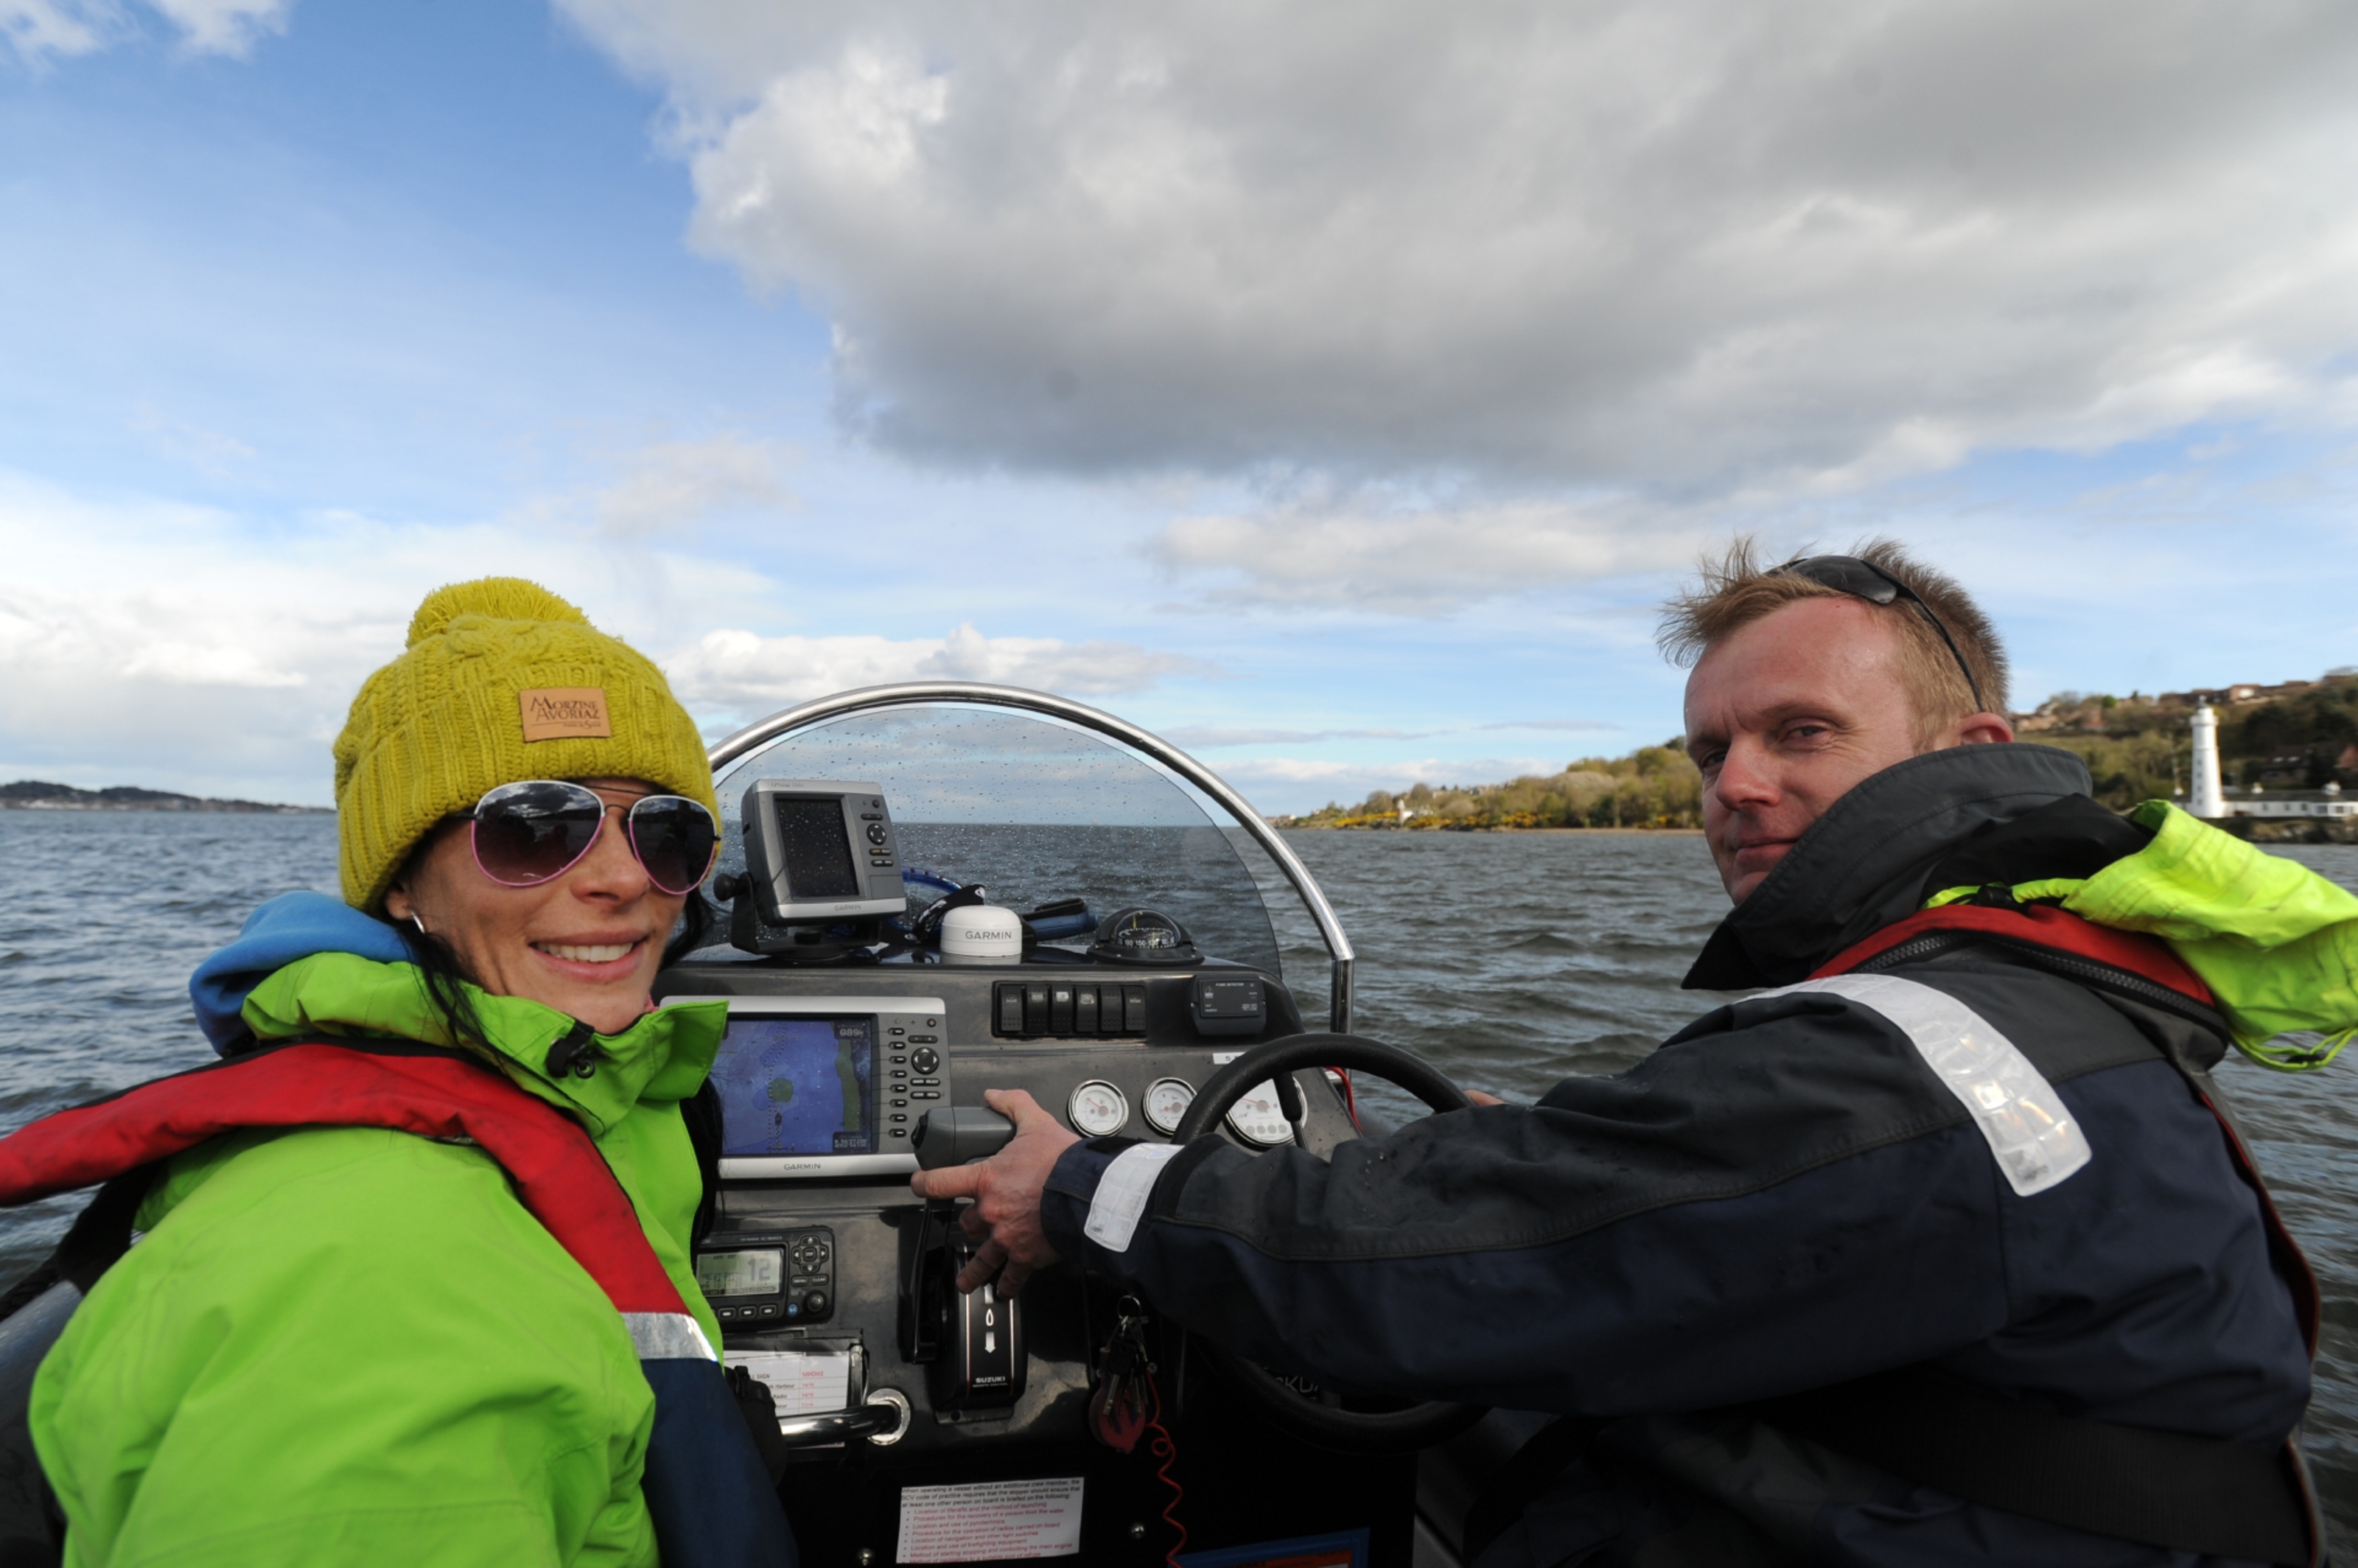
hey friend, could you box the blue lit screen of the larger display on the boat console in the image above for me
[712,1016,877,1158]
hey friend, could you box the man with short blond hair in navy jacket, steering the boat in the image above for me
[917,540,2323,1568]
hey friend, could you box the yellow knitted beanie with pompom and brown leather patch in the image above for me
[335,578,719,912]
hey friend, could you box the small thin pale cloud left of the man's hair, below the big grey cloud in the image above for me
[1146,503,1702,615]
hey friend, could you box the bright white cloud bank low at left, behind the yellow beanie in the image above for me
[0,472,802,804]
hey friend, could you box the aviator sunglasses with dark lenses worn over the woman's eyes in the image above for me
[467,778,721,896]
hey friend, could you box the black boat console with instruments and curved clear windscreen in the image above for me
[658,686,1469,1568]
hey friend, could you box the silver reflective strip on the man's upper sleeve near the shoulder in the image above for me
[1764,974,2091,1198]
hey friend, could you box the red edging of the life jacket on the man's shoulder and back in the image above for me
[1808,903,2325,1360]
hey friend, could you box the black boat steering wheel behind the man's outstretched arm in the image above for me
[1172,1035,1483,1452]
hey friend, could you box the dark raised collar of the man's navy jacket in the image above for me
[1684,743,2089,990]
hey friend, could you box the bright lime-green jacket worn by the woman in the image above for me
[31,953,724,1568]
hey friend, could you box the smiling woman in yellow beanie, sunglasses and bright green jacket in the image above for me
[0,578,794,1568]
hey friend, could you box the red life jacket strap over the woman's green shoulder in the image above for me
[0,1042,686,1313]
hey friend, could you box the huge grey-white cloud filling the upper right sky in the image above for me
[556,0,2358,497]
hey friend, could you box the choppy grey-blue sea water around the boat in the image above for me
[0,811,2358,1556]
